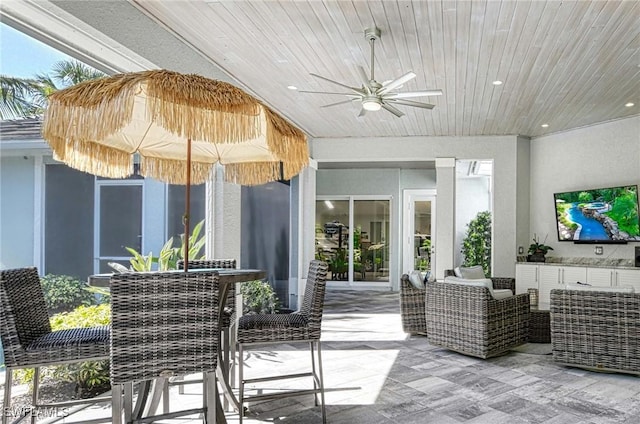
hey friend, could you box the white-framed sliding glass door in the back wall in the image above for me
[316,196,391,286]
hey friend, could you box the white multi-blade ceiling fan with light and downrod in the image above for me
[300,27,442,118]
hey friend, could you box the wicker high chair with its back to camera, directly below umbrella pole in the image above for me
[111,271,220,424]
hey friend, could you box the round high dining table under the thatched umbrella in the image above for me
[87,268,267,424]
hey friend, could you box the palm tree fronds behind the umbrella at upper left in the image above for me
[0,60,106,119]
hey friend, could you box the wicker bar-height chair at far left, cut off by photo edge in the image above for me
[0,267,110,424]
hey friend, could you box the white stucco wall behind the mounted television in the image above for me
[527,116,640,259]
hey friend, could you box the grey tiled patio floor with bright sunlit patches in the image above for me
[2,291,640,424]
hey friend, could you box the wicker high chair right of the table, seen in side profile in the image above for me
[237,260,328,423]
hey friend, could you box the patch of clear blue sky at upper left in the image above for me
[0,23,72,78]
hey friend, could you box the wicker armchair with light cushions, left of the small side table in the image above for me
[426,282,529,359]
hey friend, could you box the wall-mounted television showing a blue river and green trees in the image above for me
[553,185,640,243]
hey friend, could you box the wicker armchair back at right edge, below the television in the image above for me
[551,289,640,374]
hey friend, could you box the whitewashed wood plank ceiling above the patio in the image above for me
[134,0,640,137]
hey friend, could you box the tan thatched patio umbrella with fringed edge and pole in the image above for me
[42,70,309,271]
